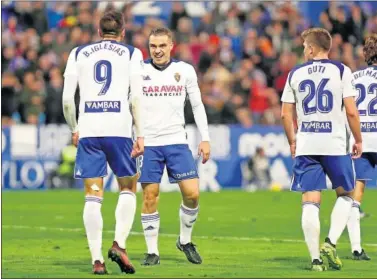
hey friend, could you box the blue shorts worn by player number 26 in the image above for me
[291,155,355,192]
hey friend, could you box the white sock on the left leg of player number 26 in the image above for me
[301,202,321,261]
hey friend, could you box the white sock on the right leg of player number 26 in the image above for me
[329,196,353,245]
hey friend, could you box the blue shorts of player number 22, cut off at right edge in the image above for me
[354,152,377,183]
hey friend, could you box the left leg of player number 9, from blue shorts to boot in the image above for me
[75,138,107,274]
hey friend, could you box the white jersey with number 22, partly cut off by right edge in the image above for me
[352,66,377,152]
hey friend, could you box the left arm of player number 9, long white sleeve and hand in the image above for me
[63,48,78,146]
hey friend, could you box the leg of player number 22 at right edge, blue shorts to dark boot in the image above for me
[347,153,375,261]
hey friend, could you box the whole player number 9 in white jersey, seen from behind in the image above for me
[63,11,144,274]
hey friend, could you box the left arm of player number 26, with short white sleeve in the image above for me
[281,76,296,158]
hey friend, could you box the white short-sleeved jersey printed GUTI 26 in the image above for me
[281,59,357,156]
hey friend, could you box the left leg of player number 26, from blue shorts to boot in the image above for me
[291,156,326,271]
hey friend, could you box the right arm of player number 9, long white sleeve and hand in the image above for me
[130,48,144,157]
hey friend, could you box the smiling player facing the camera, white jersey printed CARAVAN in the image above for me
[139,28,210,265]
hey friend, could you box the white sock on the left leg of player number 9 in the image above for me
[83,196,104,264]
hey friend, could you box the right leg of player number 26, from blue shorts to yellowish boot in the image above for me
[321,155,355,269]
